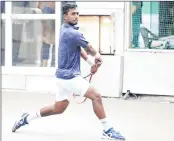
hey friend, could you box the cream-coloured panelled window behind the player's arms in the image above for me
[79,16,114,54]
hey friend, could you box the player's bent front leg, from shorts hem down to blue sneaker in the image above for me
[74,77,125,140]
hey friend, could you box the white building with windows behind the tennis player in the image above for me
[1,1,174,97]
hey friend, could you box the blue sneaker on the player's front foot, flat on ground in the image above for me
[103,128,125,140]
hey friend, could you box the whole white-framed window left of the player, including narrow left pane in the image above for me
[1,1,61,67]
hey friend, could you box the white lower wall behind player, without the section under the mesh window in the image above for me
[2,56,123,97]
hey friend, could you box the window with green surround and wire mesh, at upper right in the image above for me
[131,1,174,49]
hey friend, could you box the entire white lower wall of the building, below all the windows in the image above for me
[2,52,174,97]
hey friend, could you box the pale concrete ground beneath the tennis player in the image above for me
[2,92,174,141]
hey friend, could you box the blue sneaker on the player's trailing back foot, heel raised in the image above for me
[12,113,29,132]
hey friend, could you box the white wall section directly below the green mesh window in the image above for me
[123,52,174,96]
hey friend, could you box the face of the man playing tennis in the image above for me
[64,8,79,25]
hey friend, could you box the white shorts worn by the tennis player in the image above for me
[56,76,90,101]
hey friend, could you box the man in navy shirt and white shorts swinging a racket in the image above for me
[12,3,125,140]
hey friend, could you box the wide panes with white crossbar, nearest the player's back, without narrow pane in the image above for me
[12,1,56,67]
